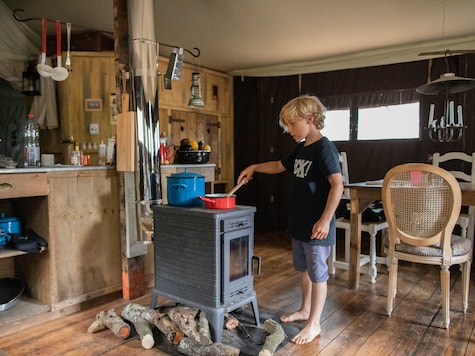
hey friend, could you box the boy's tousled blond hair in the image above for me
[279,95,326,132]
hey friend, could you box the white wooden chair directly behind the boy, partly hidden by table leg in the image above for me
[328,152,388,283]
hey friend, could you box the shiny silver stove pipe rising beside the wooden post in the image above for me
[128,0,162,248]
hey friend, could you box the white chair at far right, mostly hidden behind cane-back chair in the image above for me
[432,152,475,244]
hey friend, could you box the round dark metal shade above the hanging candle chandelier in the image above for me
[416,73,475,95]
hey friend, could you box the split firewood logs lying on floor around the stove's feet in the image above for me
[88,303,285,356]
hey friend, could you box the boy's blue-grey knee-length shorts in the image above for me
[292,239,331,283]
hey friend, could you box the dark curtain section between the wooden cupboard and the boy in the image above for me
[234,76,298,230]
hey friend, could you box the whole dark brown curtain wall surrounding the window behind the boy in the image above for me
[234,55,475,229]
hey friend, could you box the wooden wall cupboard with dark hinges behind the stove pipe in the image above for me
[159,58,234,189]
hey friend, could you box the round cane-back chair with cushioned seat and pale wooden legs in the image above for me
[382,163,472,329]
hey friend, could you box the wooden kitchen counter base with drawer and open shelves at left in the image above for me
[0,169,122,310]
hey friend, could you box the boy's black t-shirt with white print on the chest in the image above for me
[281,137,341,246]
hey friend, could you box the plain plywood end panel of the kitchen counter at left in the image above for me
[48,170,122,310]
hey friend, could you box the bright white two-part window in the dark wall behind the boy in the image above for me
[322,102,420,141]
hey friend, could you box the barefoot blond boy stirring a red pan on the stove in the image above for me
[237,95,343,344]
